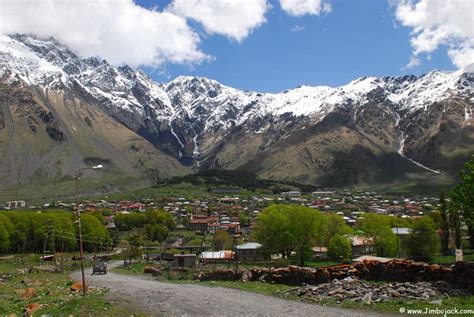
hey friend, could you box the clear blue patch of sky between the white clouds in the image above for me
[136,0,455,92]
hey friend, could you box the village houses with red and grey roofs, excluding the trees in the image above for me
[3,189,448,267]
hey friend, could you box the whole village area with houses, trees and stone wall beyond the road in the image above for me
[0,183,474,312]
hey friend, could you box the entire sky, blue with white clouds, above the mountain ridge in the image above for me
[0,0,466,92]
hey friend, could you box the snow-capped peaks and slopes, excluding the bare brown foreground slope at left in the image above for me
[0,35,474,185]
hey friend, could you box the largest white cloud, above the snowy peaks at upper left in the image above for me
[0,0,208,66]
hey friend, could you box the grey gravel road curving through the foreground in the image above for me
[72,262,386,317]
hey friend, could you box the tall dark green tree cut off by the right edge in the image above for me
[449,156,474,249]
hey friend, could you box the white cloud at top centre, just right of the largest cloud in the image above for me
[167,0,270,42]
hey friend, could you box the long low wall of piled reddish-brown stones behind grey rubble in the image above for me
[194,260,474,288]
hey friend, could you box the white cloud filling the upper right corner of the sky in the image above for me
[395,0,474,68]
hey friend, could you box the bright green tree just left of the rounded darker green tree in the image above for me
[360,213,397,257]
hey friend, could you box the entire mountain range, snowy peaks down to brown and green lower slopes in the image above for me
[0,35,474,187]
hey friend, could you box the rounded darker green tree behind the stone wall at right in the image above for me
[406,216,439,261]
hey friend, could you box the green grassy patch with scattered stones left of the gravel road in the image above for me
[0,256,141,316]
